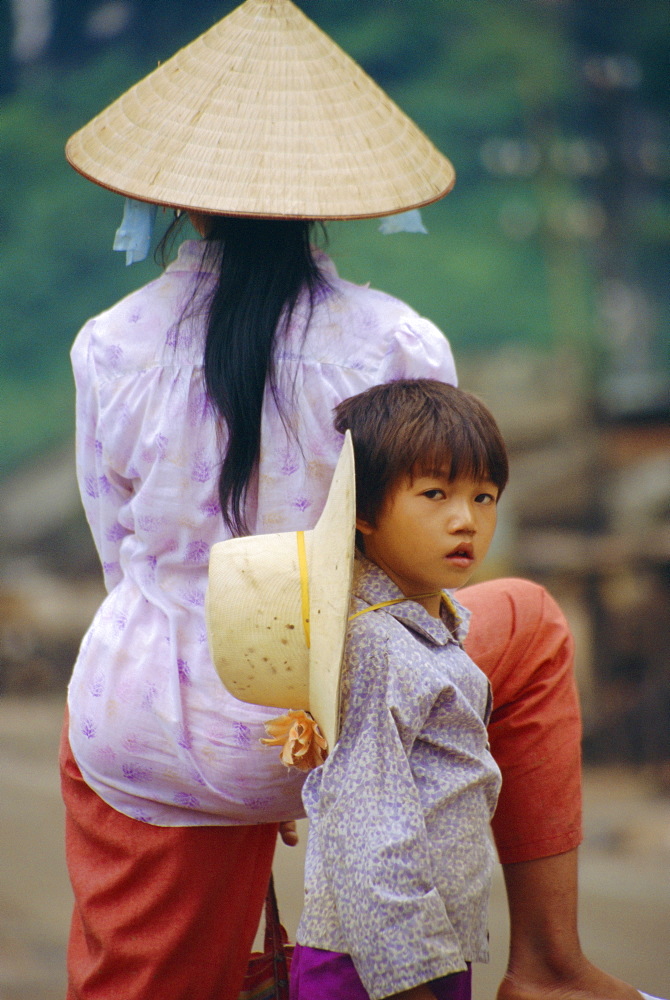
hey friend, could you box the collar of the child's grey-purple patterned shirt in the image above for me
[353,553,470,646]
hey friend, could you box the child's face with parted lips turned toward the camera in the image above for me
[356,474,498,617]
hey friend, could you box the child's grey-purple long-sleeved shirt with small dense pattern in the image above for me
[297,560,500,1000]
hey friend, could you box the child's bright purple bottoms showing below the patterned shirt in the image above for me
[290,944,472,1000]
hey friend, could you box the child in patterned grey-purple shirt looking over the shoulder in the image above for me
[291,379,508,1000]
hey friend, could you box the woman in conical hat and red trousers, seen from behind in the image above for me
[61,0,656,1000]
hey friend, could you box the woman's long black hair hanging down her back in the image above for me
[161,215,324,535]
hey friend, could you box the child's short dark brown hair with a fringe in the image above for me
[335,379,509,525]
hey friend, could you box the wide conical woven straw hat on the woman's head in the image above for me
[66,0,455,219]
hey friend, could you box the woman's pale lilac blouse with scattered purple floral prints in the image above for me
[68,241,456,826]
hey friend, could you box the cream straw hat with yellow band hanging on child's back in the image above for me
[205,432,356,747]
